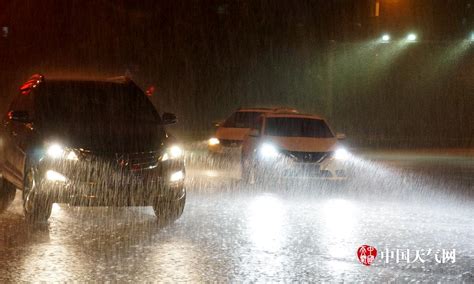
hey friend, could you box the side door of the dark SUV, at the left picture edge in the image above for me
[2,90,34,188]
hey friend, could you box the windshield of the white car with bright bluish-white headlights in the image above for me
[265,117,334,138]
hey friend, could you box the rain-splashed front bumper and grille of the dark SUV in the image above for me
[34,161,186,206]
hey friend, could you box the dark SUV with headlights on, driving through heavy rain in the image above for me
[0,75,186,222]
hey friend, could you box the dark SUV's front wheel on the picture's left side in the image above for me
[23,169,53,223]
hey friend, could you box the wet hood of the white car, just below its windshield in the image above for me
[268,136,337,152]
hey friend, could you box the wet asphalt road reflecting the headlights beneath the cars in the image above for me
[0,146,474,282]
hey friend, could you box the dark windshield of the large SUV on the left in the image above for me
[38,83,160,125]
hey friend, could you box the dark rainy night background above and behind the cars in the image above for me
[0,0,474,147]
